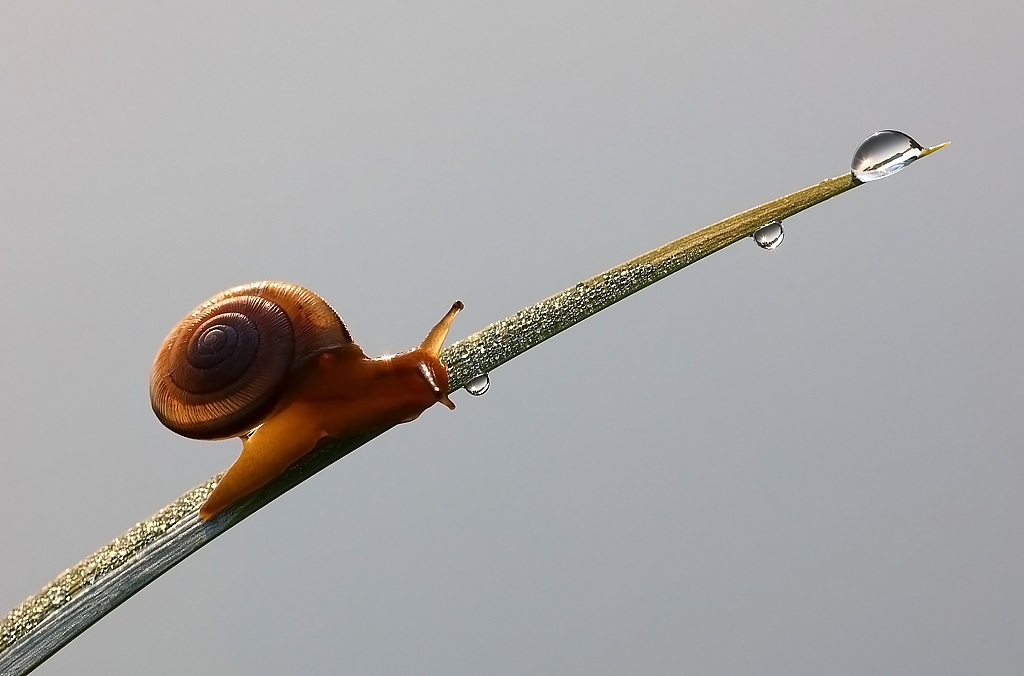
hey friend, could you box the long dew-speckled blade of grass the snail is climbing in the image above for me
[0,146,941,676]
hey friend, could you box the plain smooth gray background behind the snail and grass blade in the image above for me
[0,0,1024,675]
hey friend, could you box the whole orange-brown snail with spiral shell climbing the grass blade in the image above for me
[150,282,463,520]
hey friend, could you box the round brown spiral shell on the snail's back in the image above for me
[150,282,352,439]
